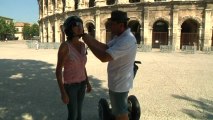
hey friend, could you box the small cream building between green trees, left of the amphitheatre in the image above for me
[15,22,30,40]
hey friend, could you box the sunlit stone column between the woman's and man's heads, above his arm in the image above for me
[95,10,100,40]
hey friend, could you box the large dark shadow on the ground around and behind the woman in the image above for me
[0,59,107,120]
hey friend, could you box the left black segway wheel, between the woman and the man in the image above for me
[98,98,110,120]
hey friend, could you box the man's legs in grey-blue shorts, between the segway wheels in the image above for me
[109,90,129,120]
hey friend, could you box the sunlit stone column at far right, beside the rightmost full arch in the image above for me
[204,9,212,47]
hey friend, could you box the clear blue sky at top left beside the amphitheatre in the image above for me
[0,0,39,23]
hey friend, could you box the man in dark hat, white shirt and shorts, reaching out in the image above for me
[82,10,137,120]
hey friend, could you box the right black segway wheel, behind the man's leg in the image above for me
[128,95,141,120]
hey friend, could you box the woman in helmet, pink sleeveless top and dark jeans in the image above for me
[56,16,91,120]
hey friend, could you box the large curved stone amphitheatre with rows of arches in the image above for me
[38,0,213,50]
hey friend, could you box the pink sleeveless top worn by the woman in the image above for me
[63,42,87,84]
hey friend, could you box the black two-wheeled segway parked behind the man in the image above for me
[98,61,141,120]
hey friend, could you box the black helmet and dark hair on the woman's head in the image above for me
[63,16,83,40]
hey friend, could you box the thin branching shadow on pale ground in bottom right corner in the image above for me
[172,95,213,120]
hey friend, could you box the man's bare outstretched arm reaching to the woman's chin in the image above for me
[82,34,113,62]
